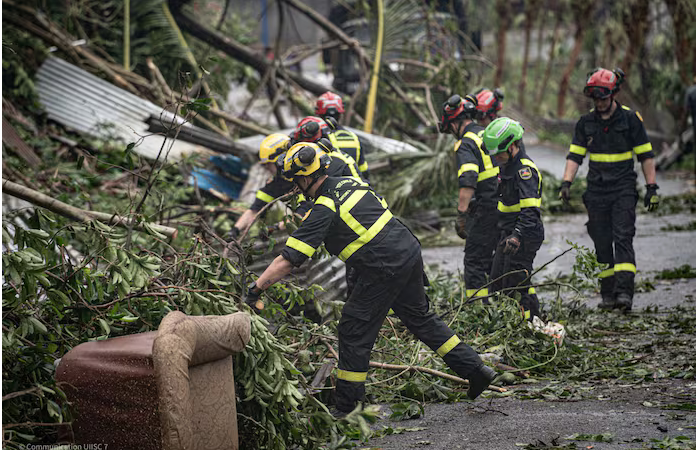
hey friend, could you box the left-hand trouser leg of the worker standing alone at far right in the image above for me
[583,192,615,297]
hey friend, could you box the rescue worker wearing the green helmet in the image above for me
[484,117,544,320]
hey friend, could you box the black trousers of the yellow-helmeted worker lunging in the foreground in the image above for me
[336,255,483,412]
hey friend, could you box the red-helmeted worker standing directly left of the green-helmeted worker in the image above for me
[438,95,499,297]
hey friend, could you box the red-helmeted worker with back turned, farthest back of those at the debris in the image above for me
[315,91,369,180]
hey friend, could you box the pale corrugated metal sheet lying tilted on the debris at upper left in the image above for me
[36,57,203,159]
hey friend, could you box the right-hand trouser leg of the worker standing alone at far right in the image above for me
[612,191,637,297]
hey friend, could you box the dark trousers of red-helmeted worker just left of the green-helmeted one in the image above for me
[464,205,500,296]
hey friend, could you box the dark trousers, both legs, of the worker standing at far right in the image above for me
[583,188,639,297]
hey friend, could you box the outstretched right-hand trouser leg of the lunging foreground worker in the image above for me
[392,257,483,378]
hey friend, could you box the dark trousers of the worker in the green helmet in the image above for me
[491,224,544,319]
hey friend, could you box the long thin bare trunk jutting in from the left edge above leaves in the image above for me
[2,178,178,239]
